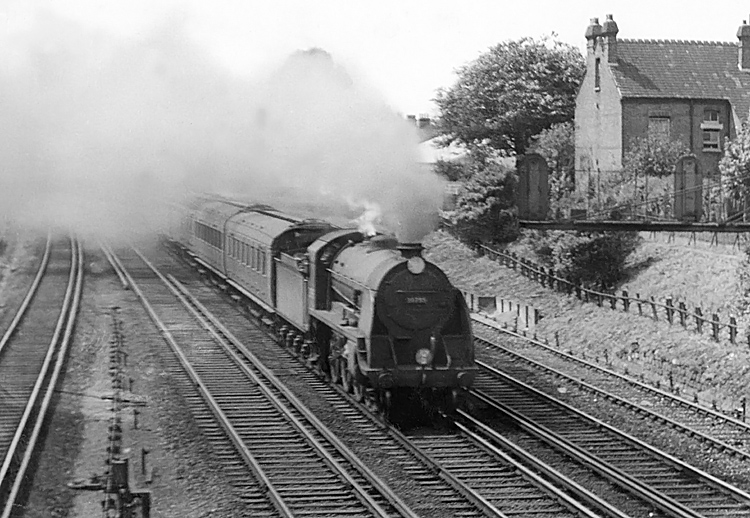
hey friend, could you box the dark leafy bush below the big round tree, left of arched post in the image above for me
[450,153,518,243]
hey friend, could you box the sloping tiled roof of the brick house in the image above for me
[612,40,750,119]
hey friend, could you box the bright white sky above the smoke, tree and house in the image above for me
[0,0,750,113]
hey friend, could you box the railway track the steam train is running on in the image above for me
[157,244,650,517]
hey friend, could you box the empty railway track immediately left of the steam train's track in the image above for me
[108,247,426,517]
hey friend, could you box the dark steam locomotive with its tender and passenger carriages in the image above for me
[172,198,476,414]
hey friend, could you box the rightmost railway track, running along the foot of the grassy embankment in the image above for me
[475,317,750,461]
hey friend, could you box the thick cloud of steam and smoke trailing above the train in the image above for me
[0,12,443,245]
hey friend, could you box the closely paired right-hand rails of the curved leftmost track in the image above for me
[0,240,83,518]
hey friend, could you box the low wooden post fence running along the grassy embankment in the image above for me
[474,244,750,345]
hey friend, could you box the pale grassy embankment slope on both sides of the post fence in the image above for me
[424,232,750,410]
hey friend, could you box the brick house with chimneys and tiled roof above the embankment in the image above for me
[575,15,750,193]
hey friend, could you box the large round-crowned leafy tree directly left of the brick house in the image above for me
[435,38,585,155]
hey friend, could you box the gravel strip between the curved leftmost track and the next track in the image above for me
[17,246,250,518]
